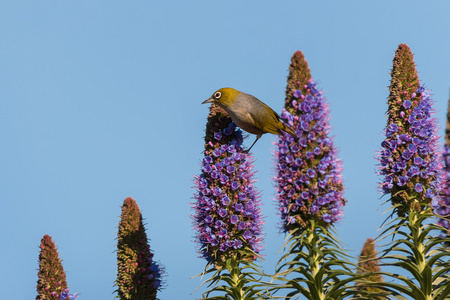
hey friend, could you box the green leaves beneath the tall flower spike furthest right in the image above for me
[372,206,450,300]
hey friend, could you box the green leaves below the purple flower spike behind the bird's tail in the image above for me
[276,221,355,300]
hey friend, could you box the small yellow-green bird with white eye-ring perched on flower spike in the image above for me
[202,88,297,152]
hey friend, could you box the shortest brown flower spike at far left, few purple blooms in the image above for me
[36,234,77,300]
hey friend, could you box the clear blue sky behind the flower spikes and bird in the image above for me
[0,0,450,299]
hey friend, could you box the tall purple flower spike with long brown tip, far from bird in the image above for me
[380,44,441,215]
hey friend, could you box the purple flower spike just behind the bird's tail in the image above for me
[275,51,346,231]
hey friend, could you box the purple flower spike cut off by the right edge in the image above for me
[436,99,450,238]
